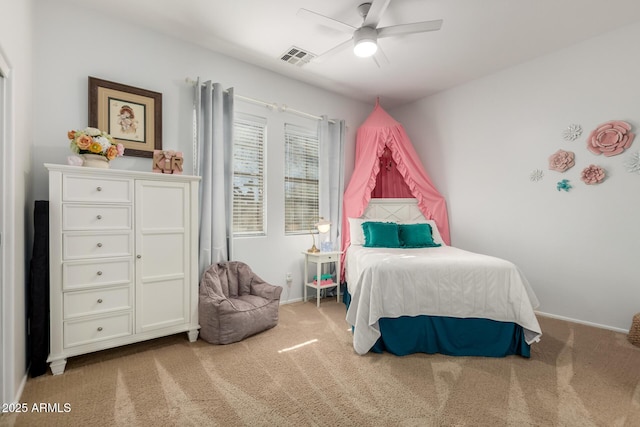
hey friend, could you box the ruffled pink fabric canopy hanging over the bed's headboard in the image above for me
[342,101,450,278]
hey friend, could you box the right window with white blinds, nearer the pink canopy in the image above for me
[284,123,318,234]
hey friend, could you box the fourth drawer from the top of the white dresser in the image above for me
[62,258,133,290]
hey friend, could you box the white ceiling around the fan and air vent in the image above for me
[62,0,640,107]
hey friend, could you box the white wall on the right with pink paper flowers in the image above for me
[391,20,640,331]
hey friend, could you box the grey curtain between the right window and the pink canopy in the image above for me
[318,116,345,250]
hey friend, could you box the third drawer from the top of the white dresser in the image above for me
[62,232,133,261]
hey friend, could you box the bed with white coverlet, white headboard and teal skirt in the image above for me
[345,199,542,357]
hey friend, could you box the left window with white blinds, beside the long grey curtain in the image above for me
[233,113,267,236]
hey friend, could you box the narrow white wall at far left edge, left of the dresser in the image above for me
[0,0,33,402]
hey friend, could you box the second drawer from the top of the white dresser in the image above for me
[62,204,131,231]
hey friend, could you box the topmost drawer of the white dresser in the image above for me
[62,175,133,203]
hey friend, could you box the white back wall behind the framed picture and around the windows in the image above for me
[32,0,372,301]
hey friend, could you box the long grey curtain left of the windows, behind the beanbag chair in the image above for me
[194,78,233,275]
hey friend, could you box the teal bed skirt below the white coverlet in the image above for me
[343,289,531,358]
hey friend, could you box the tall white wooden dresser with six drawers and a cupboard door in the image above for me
[45,164,200,375]
